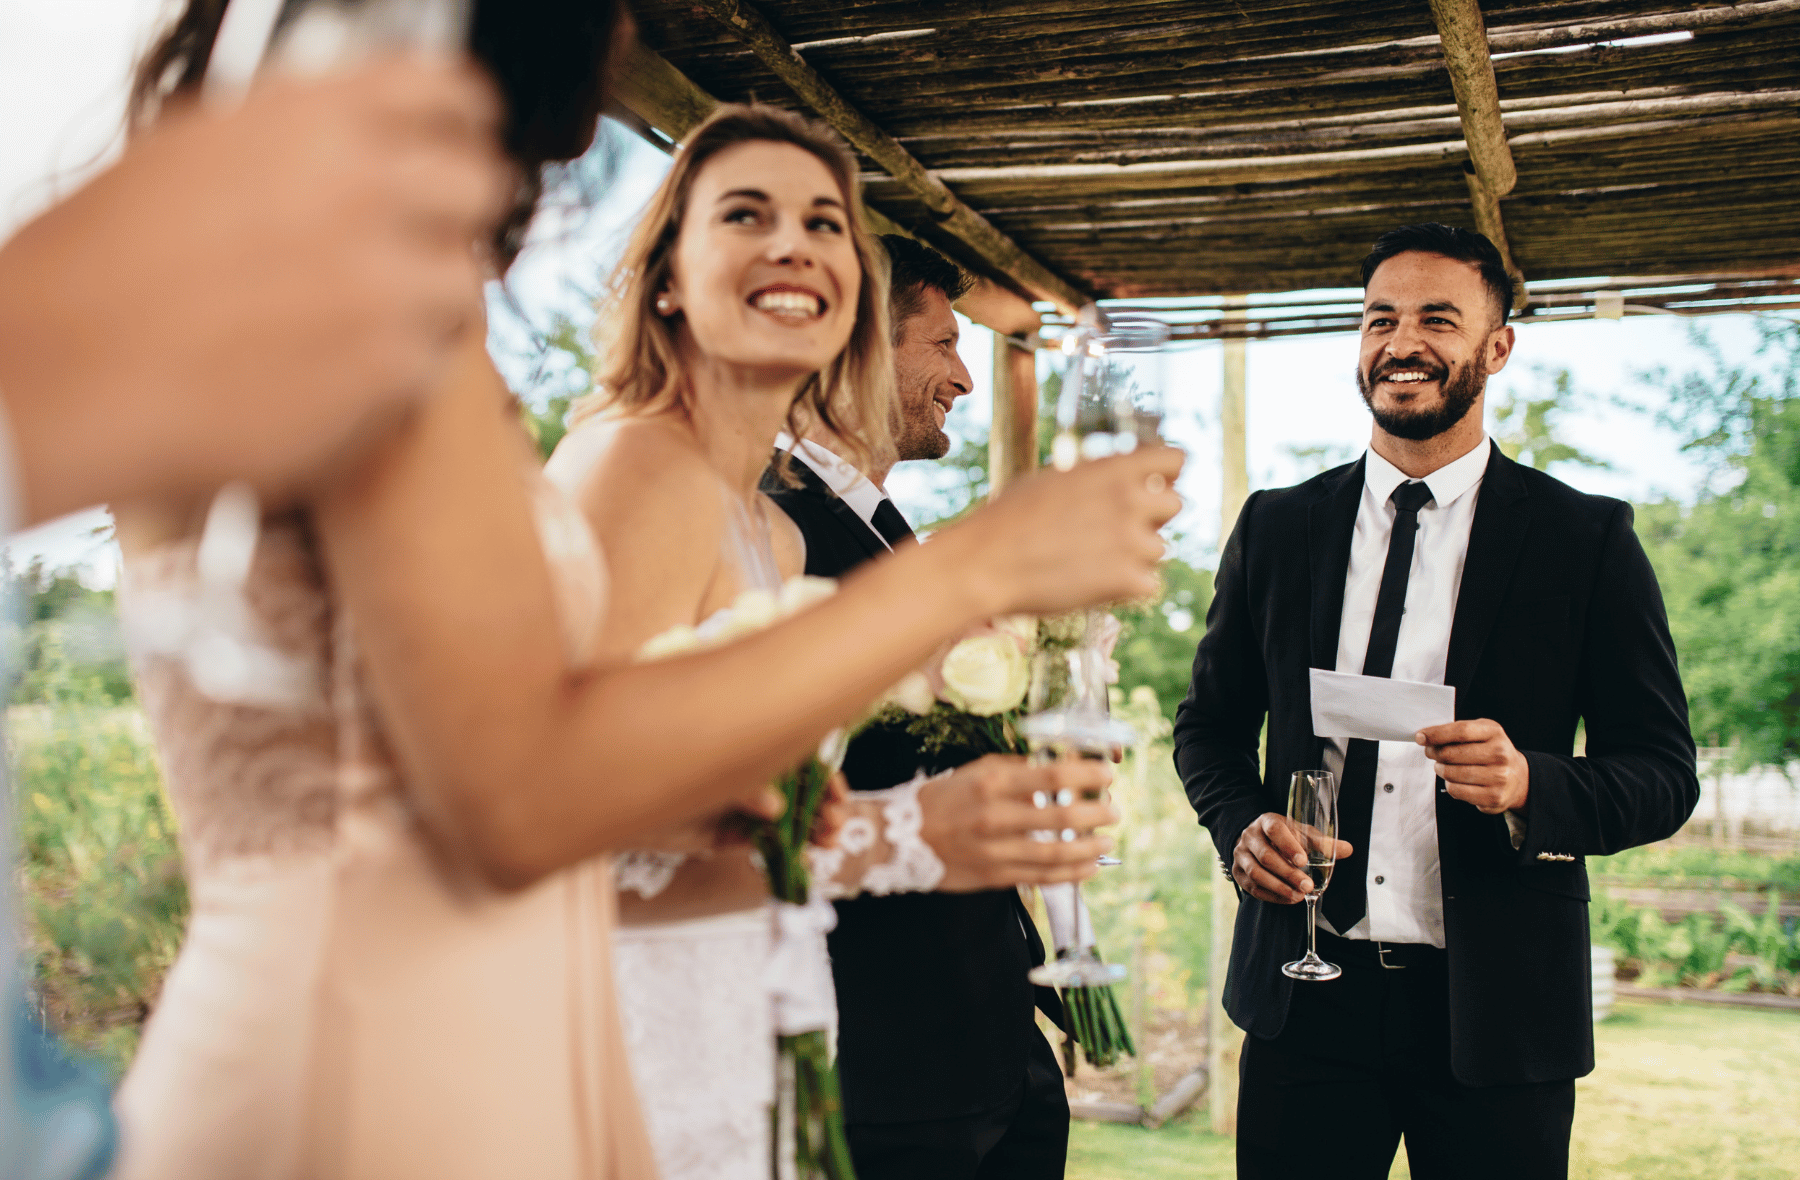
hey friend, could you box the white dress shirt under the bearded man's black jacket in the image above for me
[1319,435,1492,948]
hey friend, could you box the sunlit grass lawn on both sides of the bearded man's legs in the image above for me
[1067,1002,1800,1180]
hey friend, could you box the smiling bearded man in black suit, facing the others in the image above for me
[1175,225,1699,1180]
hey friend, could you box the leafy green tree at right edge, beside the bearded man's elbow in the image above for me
[1638,322,1800,764]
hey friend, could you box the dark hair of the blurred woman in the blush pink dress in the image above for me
[126,0,628,268]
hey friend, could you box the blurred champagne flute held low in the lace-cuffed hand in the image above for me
[1019,648,1136,988]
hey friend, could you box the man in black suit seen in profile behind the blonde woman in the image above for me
[763,236,1069,1180]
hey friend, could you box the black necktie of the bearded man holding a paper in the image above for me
[1319,480,1431,934]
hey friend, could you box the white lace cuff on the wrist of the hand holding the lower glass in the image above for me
[806,773,943,901]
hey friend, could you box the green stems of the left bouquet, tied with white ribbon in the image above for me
[751,757,857,1180]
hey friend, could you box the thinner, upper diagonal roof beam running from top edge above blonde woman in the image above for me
[684,0,1091,315]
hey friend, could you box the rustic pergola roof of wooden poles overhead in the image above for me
[621,0,1800,330]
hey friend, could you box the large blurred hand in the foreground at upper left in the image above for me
[0,58,517,520]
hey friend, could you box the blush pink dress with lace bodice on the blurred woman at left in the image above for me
[117,484,655,1180]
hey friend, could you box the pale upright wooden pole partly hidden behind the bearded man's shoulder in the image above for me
[1206,295,1249,1135]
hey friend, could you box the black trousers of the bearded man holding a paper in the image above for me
[1237,930,1575,1180]
